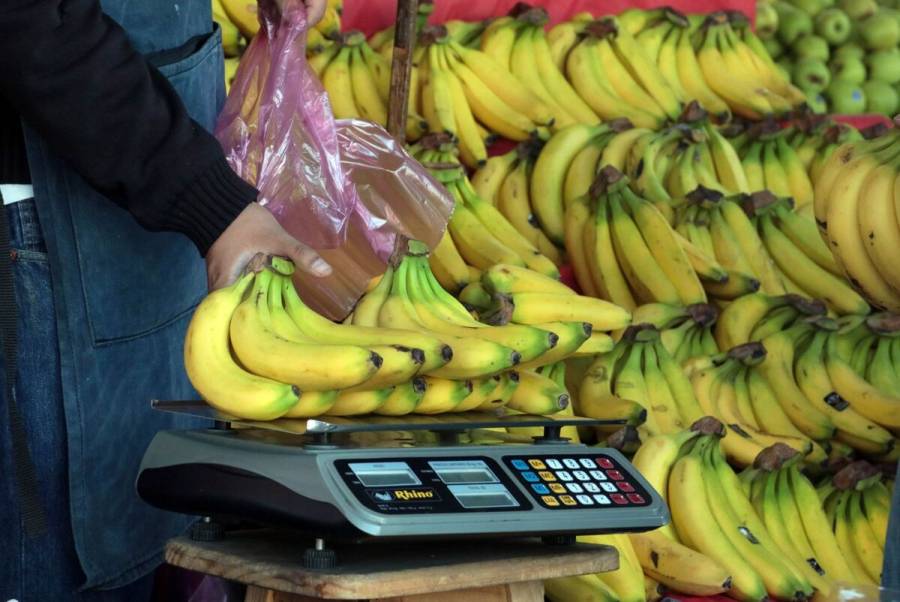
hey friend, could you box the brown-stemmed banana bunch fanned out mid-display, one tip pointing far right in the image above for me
[565,165,759,310]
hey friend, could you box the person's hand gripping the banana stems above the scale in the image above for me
[206,203,331,291]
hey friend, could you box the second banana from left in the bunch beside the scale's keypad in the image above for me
[667,438,768,600]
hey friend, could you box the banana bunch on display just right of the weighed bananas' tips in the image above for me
[575,323,703,435]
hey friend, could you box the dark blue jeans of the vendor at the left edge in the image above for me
[0,200,153,602]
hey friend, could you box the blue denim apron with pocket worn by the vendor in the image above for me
[17,0,224,589]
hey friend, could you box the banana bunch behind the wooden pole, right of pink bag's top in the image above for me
[309,32,428,141]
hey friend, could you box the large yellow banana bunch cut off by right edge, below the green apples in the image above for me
[814,120,900,311]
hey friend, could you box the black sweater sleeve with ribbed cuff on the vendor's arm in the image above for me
[0,0,257,255]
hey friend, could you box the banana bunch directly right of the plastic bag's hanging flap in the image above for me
[410,139,559,294]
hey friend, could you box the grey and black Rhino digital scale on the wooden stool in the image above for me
[137,401,669,564]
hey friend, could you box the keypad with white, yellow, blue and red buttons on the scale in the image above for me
[504,454,651,510]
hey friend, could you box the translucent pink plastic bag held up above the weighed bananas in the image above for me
[215,0,453,320]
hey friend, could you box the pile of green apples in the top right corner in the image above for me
[756,0,900,116]
